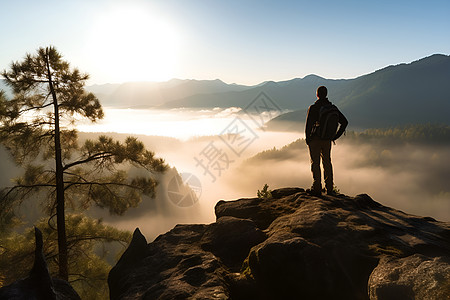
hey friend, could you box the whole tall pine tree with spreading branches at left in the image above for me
[0,47,167,280]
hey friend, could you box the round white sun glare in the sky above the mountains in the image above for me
[87,6,180,83]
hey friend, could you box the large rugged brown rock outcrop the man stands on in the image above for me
[108,188,450,300]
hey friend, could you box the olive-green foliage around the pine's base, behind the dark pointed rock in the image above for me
[0,214,131,299]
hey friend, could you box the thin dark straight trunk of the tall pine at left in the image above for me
[47,49,69,281]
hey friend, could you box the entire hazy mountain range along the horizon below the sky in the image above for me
[0,54,450,130]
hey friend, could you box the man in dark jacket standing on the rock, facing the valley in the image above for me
[305,86,348,195]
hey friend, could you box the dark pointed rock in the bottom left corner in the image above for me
[0,228,80,300]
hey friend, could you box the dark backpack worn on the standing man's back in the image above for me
[312,104,340,141]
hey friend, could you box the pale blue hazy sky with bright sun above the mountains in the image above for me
[0,0,450,84]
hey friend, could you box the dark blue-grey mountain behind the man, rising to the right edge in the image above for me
[267,54,450,130]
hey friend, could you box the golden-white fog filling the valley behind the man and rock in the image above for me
[2,109,450,241]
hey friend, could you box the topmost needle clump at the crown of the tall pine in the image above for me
[2,47,103,121]
